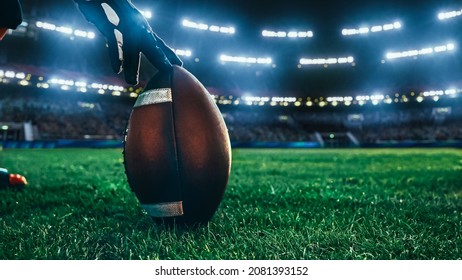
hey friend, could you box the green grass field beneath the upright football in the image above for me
[0,149,462,260]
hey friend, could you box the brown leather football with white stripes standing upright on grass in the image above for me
[124,66,231,224]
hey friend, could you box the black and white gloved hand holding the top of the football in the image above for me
[74,0,183,85]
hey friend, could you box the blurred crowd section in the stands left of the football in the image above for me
[0,91,126,140]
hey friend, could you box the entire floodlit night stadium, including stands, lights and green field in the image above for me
[0,0,462,260]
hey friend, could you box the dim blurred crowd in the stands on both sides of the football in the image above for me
[0,89,462,144]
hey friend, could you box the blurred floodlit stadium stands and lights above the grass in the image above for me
[0,0,462,148]
